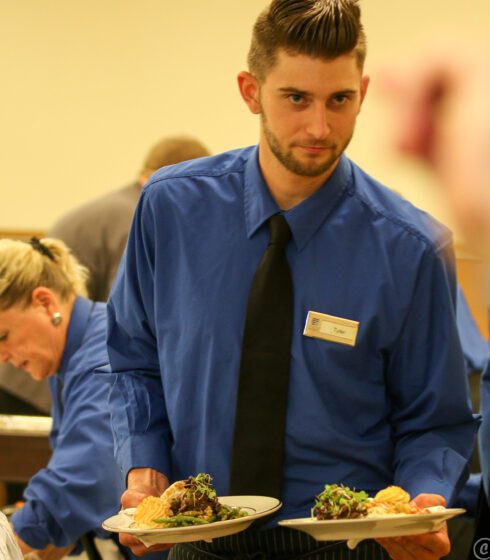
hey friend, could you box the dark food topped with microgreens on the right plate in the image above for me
[312,484,369,520]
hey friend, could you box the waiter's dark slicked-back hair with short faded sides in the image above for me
[248,0,366,81]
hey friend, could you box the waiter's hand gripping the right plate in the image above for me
[376,494,451,560]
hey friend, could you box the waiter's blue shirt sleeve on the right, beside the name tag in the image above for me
[387,246,478,504]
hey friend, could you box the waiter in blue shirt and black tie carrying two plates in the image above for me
[108,0,476,560]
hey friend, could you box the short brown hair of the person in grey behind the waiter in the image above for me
[140,136,211,176]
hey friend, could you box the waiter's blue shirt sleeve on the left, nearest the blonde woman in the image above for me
[107,192,172,482]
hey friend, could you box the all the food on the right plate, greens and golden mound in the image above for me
[311,484,427,520]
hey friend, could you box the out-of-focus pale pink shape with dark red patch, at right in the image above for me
[383,39,490,259]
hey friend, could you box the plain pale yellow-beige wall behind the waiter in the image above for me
[0,0,490,234]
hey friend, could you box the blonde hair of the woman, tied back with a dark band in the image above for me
[0,238,88,311]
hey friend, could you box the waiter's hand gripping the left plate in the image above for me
[119,469,172,556]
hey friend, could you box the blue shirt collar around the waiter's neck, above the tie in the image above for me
[244,147,352,250]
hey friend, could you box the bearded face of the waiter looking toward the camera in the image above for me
[258,50,368,177]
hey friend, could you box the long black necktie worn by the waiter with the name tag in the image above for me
[229,214,293,498]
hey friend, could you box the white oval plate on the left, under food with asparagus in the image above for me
[102,496,282,546]
